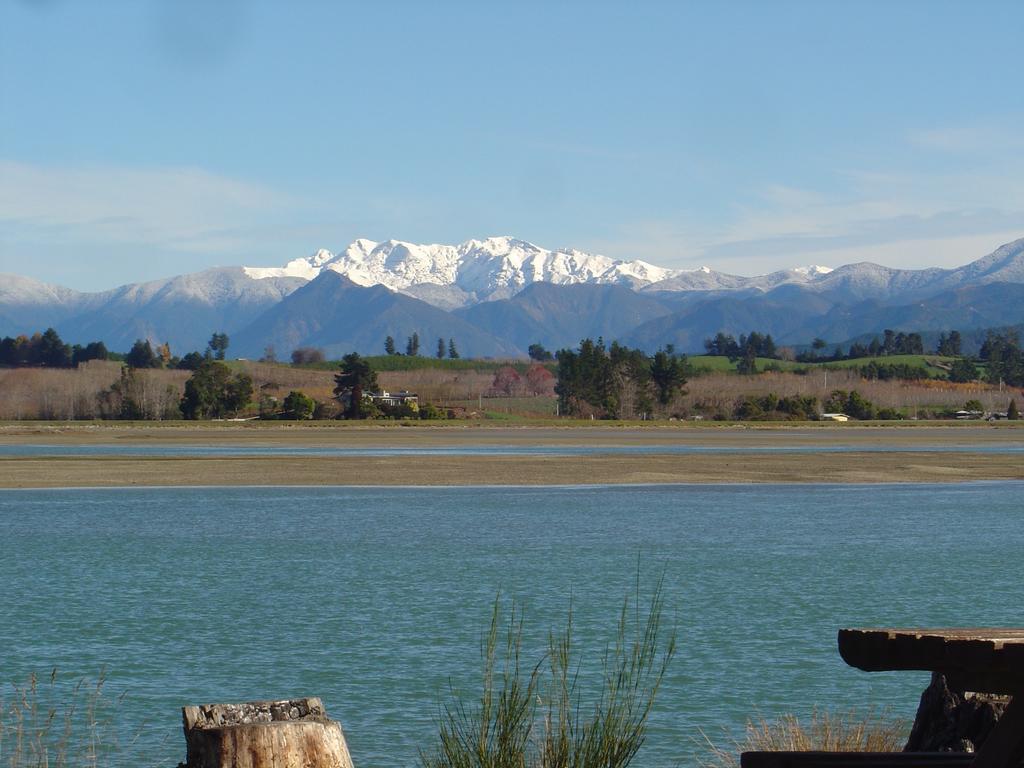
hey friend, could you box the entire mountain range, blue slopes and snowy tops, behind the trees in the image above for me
[0,238,1024,357]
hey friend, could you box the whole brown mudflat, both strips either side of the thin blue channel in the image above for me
[0,423,1024,488]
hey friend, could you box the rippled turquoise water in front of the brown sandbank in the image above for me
[0,483,1024,768]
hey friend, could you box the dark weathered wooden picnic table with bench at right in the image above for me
[740,629,1024,768]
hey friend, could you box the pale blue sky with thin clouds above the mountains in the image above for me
[0,0,1024,290]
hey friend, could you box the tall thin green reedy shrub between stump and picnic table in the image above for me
[420,581,676,768]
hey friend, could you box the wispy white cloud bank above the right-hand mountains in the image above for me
[600,124,1024,274]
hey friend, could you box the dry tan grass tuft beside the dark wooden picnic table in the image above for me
[699,710,907,768]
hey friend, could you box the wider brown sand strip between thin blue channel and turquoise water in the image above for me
[0,452,1024,488]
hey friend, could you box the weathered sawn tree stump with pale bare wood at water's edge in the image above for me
[181,697,352,768]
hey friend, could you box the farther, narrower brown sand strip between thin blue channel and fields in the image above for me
[6,421,1024,449]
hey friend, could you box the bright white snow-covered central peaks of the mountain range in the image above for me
[246,237,678,308]
